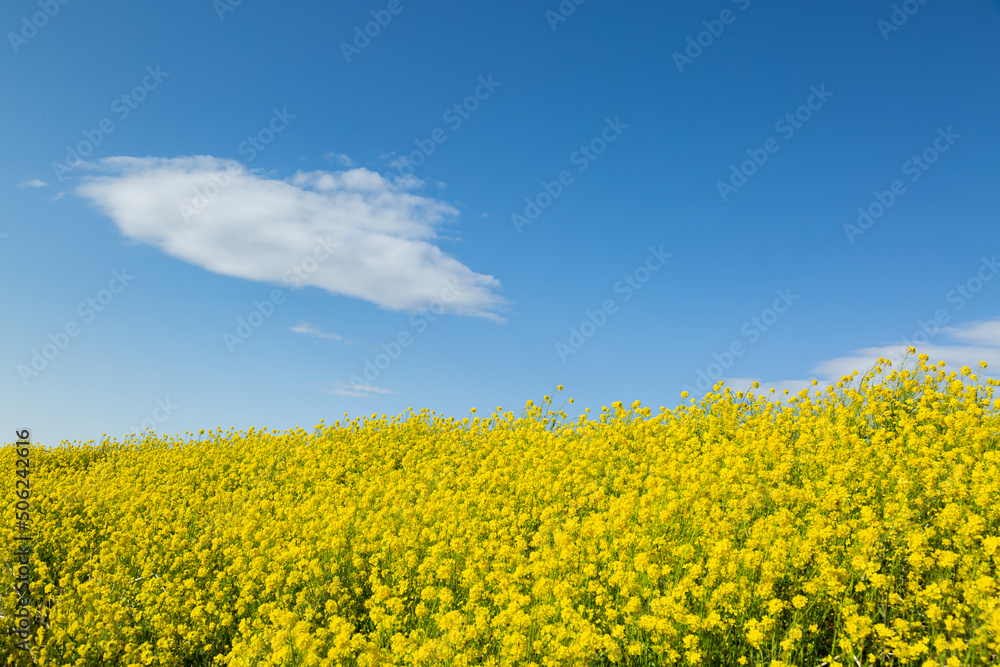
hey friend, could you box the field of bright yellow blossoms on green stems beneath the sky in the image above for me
[0,349,1000,667]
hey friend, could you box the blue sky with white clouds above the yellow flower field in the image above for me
[0,0,1000,444]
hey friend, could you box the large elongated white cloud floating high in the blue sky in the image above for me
[76,156,505,322]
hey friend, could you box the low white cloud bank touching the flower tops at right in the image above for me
[712,318,1000,399]
